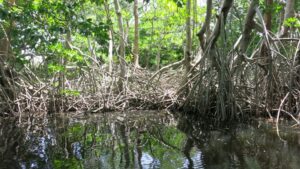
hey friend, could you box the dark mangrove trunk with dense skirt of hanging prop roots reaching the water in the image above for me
[184,0,237,121]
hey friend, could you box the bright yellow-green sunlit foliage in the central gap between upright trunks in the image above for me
[129,0,205,67]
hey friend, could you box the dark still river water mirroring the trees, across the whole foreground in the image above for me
[0,111,300,169]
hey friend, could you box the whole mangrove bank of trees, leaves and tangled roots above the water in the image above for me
[0,0,300,122]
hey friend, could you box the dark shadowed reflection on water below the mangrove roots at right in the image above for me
[178,116,300,169]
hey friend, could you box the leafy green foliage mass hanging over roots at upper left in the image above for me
[0,0,109,73]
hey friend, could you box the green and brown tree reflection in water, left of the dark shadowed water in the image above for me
[0,111,197,168]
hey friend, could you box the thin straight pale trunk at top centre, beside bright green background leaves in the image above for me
[133,0,139,68]
